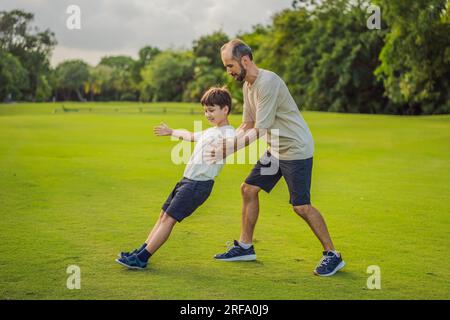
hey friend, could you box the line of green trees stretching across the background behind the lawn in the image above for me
[0,0,450,115]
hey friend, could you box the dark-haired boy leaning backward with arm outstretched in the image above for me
[116,87,234,269]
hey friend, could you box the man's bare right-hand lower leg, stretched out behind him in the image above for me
[293,204,334,251]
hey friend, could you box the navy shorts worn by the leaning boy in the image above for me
[162,178,214,222]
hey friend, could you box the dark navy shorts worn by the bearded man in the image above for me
[245,151,313,206]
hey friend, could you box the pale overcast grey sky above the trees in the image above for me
[0,0,292,65]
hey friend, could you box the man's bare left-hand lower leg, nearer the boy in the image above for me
[240,183,261,243]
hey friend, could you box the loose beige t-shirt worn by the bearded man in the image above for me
[243,69,314,160]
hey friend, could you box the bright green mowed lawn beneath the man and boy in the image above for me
[0,103,450,299]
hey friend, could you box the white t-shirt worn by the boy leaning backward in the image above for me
[183,125,236,181]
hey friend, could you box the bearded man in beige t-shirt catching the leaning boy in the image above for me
[209,39,345,276]
